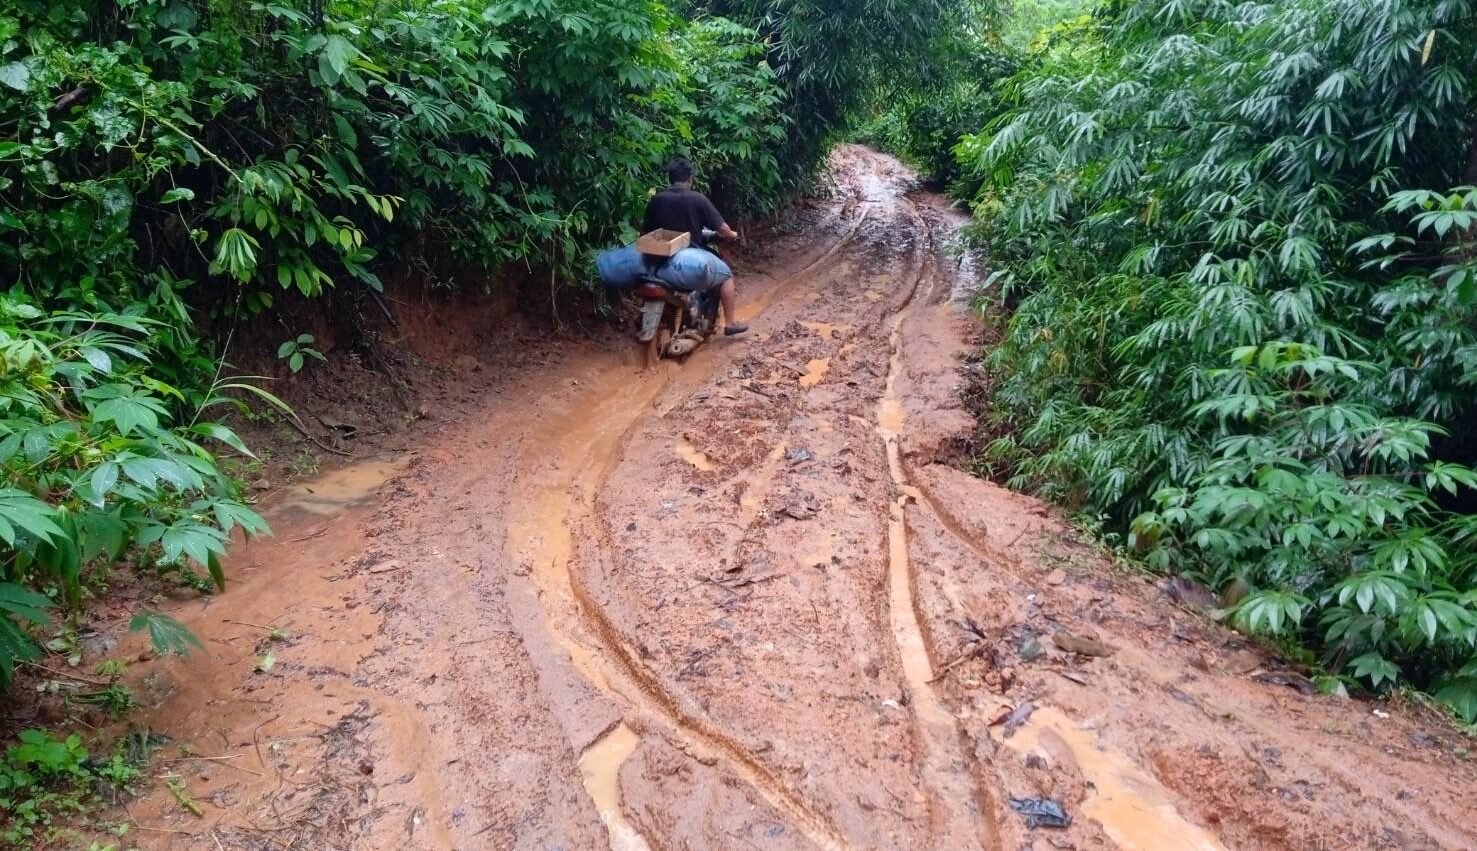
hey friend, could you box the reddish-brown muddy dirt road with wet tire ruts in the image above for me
[131,148,1477,851]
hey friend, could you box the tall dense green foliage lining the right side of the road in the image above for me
[959,0,1477,721]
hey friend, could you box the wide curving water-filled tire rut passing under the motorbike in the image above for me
[510,202,873,851]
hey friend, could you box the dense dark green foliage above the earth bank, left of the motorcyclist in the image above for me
[0,0,783,313]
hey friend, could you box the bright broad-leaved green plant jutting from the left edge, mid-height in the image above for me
[0,295,266,683]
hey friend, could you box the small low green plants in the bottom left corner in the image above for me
[0,730,140,848]
